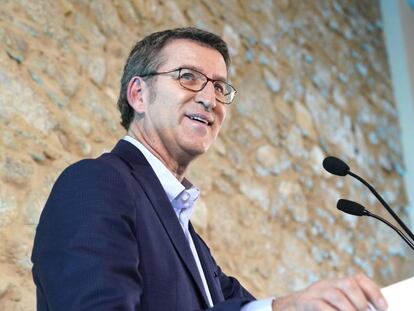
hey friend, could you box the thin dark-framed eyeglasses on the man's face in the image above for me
[140,68,237,105]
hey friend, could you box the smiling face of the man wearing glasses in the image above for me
[141,39,227,165]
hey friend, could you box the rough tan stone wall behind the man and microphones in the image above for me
[0,0,414,310]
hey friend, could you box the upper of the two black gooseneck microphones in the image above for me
[322,156,414,241]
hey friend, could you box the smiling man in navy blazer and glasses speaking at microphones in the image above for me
[32,28,386,311]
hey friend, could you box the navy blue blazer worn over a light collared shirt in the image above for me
[32,140,254,311]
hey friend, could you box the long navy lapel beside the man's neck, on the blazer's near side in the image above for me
[112,140,208,307]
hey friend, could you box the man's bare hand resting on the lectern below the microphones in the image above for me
[272,274,388,311]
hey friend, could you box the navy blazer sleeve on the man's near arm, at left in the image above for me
[32,160,142,311]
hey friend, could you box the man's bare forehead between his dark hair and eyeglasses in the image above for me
[159,39,227,79]
